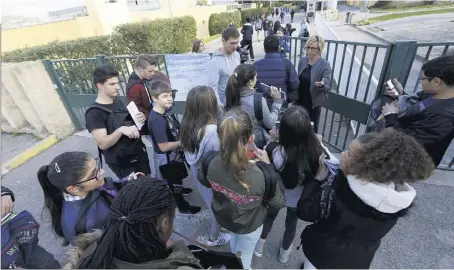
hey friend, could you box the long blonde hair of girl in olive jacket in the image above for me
[218,107,253,192]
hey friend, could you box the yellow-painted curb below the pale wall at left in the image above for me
[2,135,58,176]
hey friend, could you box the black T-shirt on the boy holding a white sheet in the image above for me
[85,104,145,167]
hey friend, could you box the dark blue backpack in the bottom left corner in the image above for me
[2,211,39,269]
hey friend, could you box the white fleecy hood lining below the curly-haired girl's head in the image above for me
[347,175,416,214]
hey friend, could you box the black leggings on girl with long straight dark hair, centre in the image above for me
[260,207,298,250]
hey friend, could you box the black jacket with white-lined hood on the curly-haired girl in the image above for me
[297,171,416,269]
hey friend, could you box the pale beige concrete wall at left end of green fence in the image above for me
[1,61,74,138]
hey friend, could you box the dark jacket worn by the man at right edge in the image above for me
[385,93,454,166]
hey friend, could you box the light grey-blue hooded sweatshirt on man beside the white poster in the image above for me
[208,49,241,105]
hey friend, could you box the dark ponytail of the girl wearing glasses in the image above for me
[38,165,63,237]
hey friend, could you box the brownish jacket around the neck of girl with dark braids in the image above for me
[63,230,202,269]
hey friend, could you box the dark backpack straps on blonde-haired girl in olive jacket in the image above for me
[200,151,279,208]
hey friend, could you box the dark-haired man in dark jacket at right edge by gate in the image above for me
[382,55,454,166]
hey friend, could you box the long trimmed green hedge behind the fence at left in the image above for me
[2,16,197,62]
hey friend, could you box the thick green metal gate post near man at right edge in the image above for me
[383,40,418,95]
